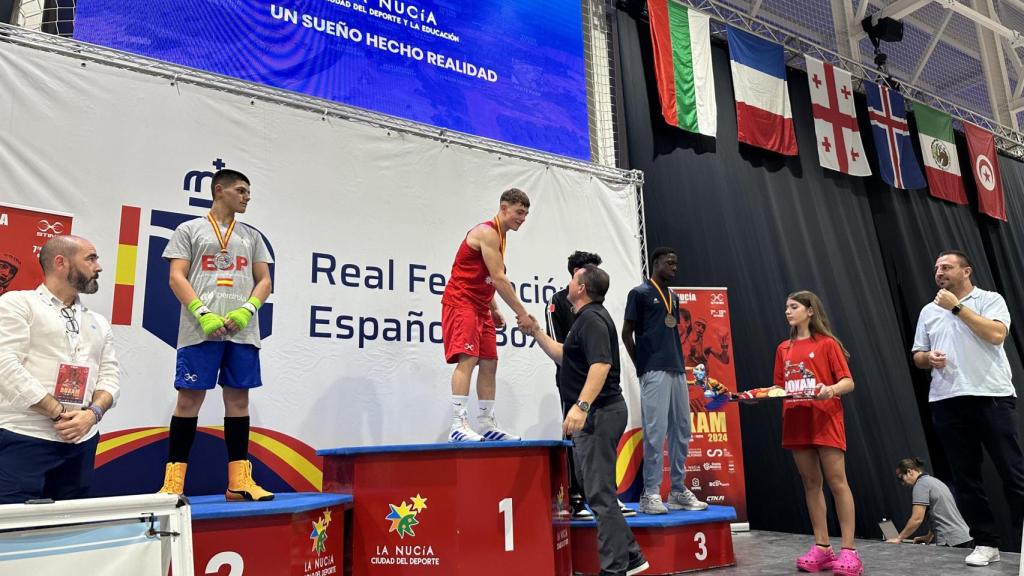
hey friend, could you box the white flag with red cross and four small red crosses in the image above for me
[804,55,871,176]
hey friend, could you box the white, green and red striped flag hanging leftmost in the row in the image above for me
[647,0,718,137]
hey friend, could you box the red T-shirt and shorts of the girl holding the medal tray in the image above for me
[774,336,852,451]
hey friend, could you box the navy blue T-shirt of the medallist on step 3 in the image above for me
[626,280,684,375]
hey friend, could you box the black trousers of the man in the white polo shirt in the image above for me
[931,396,1024,547]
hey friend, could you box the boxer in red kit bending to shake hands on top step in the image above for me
[441,188,538,442]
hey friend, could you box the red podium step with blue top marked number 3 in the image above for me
[571,504,736,576]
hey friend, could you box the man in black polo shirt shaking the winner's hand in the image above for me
[532,264,648,576]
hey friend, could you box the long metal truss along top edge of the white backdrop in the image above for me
[0,24,643,186]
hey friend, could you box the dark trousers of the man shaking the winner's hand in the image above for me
[572,402,640,575]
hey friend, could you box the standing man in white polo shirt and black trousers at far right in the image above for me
[911,251,1024,566]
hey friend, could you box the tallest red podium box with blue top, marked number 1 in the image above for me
[317,441,571,576]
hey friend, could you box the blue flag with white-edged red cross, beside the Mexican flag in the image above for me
[864,82,926,190]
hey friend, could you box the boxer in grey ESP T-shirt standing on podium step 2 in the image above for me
[160,169,273,500]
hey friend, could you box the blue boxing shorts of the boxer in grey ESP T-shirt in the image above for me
[174,340,263,390]
